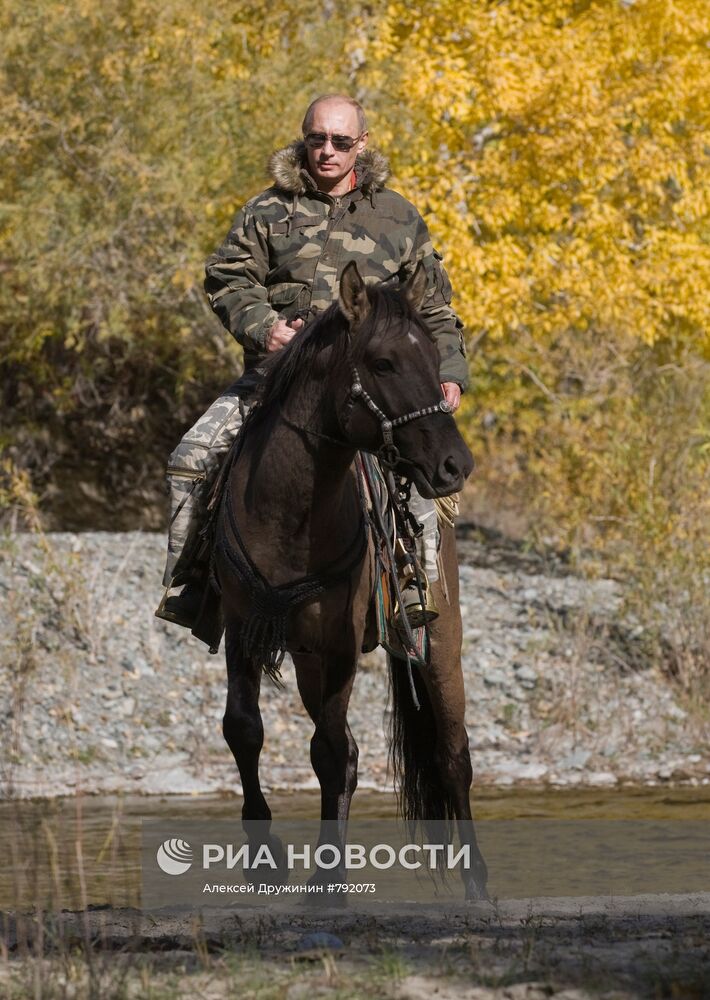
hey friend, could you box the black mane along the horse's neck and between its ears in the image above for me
[250,285,432,430]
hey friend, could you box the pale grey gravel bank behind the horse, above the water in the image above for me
[0,532,710,796]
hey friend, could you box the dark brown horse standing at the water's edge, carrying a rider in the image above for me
[215,263,487,899]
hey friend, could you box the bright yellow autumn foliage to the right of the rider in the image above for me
[351,0,710,545]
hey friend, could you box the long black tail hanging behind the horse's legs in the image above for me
[387,654,454,830]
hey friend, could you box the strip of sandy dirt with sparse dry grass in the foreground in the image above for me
[0,894,710,1000]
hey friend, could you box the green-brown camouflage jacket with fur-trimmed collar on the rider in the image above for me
[205,142,468,388]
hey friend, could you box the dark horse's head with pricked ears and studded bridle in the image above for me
[339,261,473,497]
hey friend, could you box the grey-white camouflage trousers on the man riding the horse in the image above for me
[163,388,438,587]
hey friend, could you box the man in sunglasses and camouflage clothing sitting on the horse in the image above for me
[156,94,468,628]
